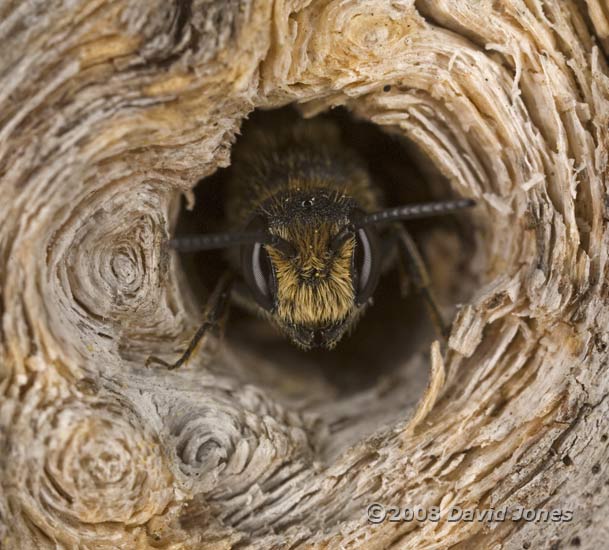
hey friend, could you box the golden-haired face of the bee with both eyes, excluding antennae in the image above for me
[241,198,380,349]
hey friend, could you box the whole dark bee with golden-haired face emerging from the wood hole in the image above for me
[149,119,474,369]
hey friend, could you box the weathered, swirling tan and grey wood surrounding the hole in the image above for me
[0,0,609,549]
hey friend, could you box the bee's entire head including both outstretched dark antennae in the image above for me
[170,194,475,349]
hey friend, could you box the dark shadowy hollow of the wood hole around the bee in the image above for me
[175,107,474,397]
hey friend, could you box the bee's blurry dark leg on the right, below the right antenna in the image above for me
[394,224,448,341]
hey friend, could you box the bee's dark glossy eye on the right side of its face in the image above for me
[352,227,380,305]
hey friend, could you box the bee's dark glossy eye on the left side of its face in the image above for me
[241,218,276,310]
